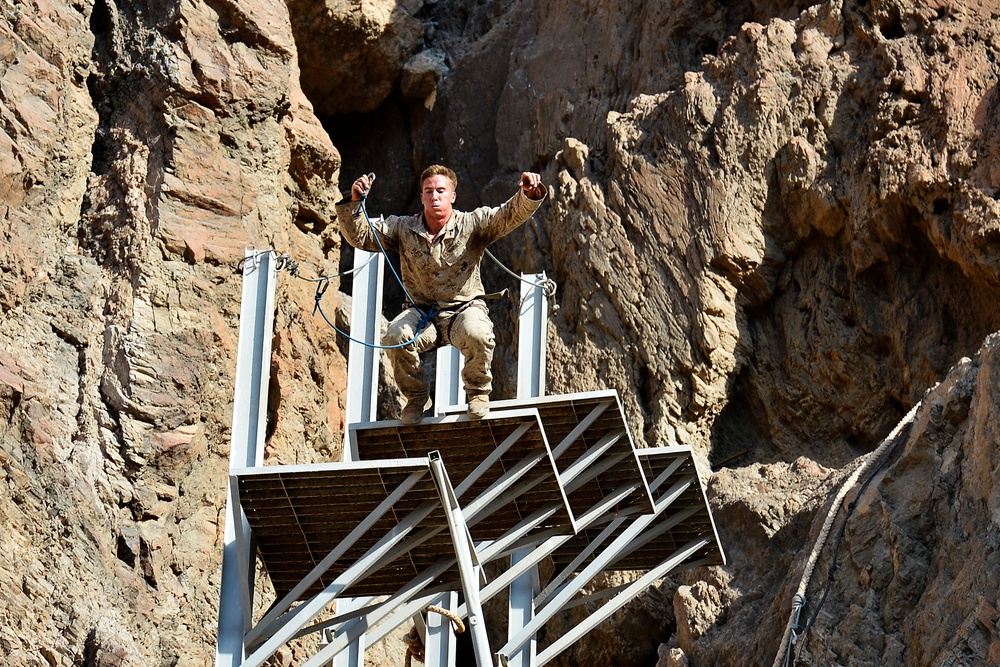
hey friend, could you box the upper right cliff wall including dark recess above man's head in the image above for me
[316,0,1000,465]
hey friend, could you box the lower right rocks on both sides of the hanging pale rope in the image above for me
[664,335,1000,665]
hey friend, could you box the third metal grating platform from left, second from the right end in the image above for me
[446,389,653,523]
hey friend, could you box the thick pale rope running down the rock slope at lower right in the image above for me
[774,401,923,667]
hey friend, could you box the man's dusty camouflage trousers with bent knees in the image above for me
[382,300,496,400]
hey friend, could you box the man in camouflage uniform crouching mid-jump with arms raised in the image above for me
[337,165,546,424]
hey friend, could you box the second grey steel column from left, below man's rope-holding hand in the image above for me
[332,249,385,667]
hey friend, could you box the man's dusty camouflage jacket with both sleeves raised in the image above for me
[337,190,545,307]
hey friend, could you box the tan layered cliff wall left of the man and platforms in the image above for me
[0,0,344,665]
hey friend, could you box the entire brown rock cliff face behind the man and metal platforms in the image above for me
[0,0,1000,667]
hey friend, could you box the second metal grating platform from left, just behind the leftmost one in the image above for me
[348,410,576,541]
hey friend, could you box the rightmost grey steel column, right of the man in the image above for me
[507,273,549,667]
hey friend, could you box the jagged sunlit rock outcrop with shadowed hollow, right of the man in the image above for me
[547,3,1000,463]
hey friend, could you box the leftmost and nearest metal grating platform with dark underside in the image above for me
[233,458,457,599]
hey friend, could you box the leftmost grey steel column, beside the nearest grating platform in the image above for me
[215,250,276,667]
